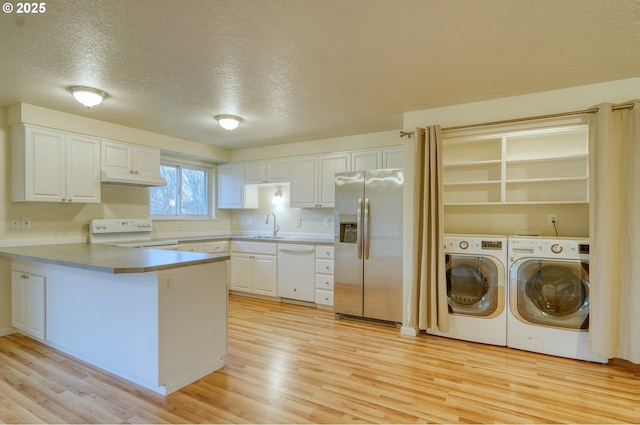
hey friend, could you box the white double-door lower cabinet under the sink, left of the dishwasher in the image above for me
[229,241,278,297]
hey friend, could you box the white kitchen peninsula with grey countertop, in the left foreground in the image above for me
[0,243,229,395]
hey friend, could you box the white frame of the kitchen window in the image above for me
[149,157,216,221]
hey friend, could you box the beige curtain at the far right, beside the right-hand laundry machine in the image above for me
[589,101,640,363]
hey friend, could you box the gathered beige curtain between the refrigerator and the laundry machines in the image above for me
[405,125,449,332]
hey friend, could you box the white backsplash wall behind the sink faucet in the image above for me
[231,184,333,237]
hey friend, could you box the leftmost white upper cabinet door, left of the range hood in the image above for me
[24,127,66,202]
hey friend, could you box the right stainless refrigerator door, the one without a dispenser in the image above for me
[362,170,404,322]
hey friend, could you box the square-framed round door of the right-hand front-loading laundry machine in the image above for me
[512,259,589,329]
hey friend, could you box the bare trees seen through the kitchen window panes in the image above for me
[150,164,211,217]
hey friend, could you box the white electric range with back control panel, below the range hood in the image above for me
[89,218,178,249]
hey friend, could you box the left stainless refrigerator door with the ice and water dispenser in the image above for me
[333,172,364,316]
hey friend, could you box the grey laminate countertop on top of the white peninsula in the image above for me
[0,243,229,274]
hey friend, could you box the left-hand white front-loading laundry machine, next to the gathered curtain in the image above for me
[427,235,508,346]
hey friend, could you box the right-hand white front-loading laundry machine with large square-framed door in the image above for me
[507,236,607,363]
